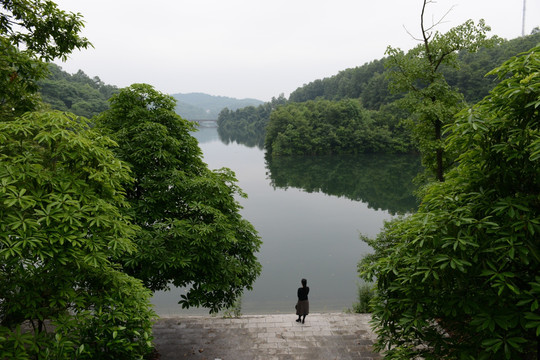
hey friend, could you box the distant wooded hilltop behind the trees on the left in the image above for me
[38,63,118,118]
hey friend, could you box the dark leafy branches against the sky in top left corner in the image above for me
[0,0,91,120]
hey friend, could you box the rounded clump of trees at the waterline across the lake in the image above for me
[265,99,413,156]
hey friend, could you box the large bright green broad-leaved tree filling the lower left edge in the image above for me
[0,112,153,359]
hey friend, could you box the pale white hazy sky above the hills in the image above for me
[52,0,540,101]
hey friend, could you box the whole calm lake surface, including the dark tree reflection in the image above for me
[153,128,420,315]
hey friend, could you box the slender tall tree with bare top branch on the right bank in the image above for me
[386,0,494,181]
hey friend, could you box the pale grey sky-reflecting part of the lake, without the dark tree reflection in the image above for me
[153,129,391,314]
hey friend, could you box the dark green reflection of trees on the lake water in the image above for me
[266,154,422,214]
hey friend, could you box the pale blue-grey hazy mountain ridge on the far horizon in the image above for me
[171,93,264,120]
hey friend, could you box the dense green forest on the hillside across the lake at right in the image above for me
[218,29,540,155]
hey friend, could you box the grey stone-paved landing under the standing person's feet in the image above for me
[154,313,382,360]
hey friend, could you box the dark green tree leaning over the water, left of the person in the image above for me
[97,84,261,312]
